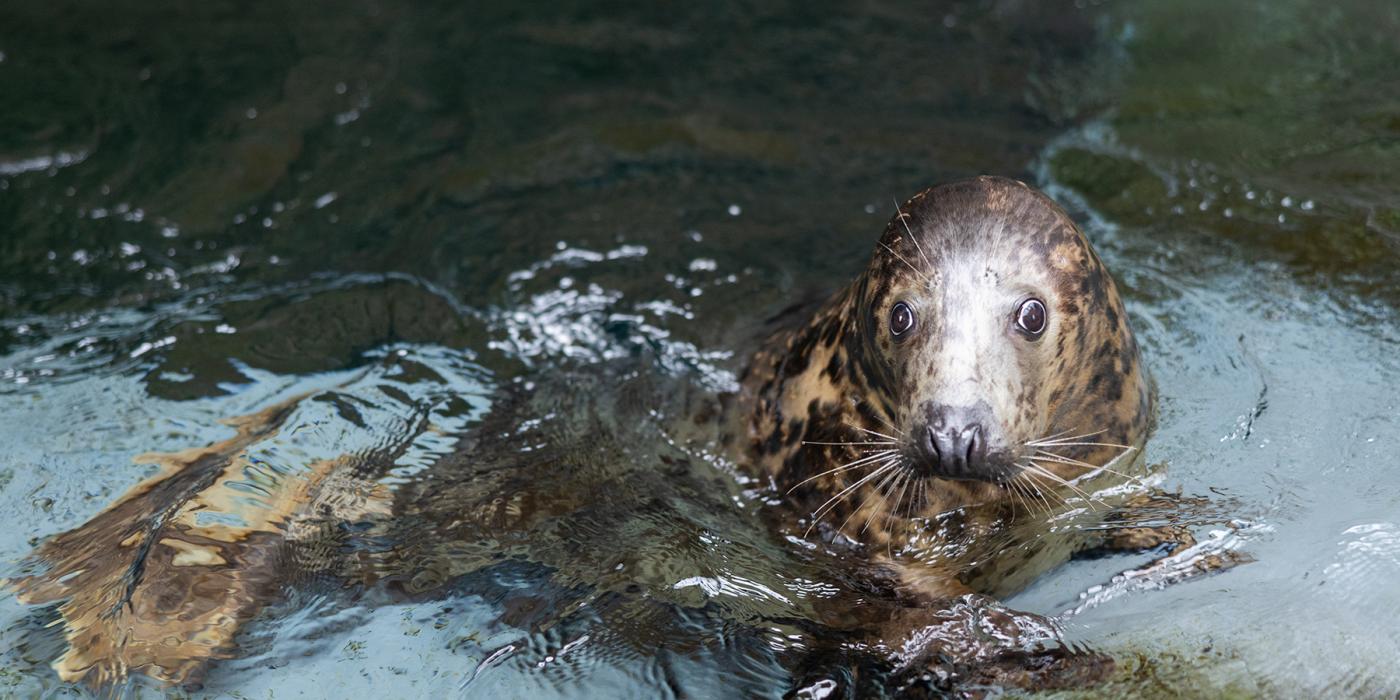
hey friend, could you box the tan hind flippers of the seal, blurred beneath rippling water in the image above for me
[6,396,388,687]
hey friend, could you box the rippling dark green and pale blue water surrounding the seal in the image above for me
[0,1,1400,697]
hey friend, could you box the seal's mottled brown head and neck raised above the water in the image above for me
[743,178,1152,543]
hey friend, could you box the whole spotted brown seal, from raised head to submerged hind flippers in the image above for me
[8,178,1181,687]
